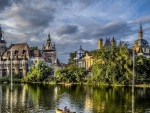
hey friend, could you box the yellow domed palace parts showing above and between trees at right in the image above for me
[74,24,150,70]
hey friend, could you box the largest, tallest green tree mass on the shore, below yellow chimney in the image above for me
[92,42,132,84]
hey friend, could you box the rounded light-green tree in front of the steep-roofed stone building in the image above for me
[23,60,53,82]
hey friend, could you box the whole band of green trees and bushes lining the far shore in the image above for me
[0,42,150,85]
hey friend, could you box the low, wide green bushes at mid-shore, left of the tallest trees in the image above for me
[56,64,87,83]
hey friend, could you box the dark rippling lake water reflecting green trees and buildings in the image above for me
[0,84,150,113]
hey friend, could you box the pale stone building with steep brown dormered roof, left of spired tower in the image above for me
[0,43,41,77]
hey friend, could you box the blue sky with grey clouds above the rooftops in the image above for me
[0,0,150,63]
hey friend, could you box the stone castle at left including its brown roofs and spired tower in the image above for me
[0,27,61,78]
